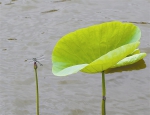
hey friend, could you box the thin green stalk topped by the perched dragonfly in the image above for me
[34,62,39,115]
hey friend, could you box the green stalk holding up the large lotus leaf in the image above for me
[102,71,106,115]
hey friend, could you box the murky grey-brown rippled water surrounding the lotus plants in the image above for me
[0,0,150,115]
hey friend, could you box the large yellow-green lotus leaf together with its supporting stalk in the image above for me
[52,21,146,115]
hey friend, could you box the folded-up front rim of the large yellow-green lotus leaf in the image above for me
[52,42,139,76]
